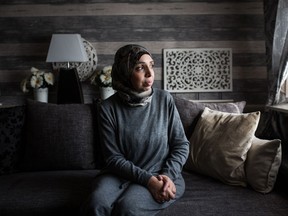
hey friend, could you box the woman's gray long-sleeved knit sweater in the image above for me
[99,89,189,186]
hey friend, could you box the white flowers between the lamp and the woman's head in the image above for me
[91,65,112,87]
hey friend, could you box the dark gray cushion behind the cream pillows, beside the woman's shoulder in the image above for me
[174,96,246,139]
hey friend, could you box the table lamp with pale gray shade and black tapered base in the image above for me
[46,34,88,104]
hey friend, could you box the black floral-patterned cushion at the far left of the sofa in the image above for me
[0,106,25,175]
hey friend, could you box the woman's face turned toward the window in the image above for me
[131,54,155,92]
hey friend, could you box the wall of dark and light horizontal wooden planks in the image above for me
[0,0,267,107]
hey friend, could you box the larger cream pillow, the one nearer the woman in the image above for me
[185,107,260,186]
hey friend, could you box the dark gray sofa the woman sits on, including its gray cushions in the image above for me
[0,97,288,216]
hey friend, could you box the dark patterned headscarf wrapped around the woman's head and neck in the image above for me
[112,44,152,106]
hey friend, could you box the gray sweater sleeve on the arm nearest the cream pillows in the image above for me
[162,96,189,181]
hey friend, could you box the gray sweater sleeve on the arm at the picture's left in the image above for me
[99,103,152,186]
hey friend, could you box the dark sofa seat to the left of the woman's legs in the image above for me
[0,170,99,216]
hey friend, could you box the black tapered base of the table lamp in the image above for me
[57,68,84,104]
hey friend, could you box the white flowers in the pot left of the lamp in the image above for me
[21,67,54,92]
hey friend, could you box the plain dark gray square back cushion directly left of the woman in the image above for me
[22,100,96,170]
